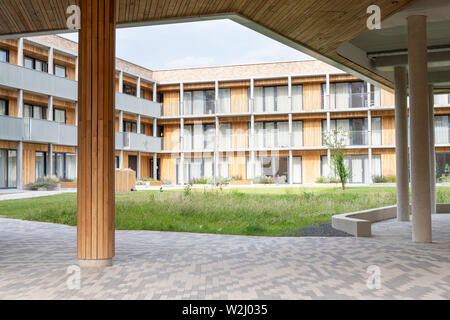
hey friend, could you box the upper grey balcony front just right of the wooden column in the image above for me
[116,92,161,118]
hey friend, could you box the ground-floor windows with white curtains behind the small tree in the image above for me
[320,154,382,183]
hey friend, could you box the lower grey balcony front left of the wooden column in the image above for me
[23,118,78,146]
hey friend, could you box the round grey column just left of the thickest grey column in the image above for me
[394,67,409,221]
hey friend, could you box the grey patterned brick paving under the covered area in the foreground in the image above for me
[0,215,450,299]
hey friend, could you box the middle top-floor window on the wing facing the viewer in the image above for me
[253,86,303,113]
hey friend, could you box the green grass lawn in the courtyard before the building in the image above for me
[0,187,450,236]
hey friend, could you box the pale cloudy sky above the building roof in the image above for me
[62,20,311,70]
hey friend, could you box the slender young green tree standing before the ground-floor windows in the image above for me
[324,128,351,190]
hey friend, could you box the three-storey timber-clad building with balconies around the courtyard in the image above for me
[0,36,450,189]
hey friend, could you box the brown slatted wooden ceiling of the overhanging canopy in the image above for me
[0,0,414,87]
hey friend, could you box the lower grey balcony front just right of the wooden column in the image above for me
[116,132,162,153]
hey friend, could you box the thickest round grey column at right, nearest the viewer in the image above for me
[408,15,432,243]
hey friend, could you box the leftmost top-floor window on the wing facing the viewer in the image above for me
[183,90,216,115]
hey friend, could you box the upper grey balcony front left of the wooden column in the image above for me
[0,62,78,101]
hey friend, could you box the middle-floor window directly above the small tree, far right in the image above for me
[322,117,382,146]
